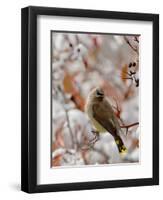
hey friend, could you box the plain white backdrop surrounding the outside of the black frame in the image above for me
[0,0,163,200]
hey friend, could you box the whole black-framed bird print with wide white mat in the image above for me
[21,6,159,193]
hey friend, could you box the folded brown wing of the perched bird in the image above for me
[92,101,117,136]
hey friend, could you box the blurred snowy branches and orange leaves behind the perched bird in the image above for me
[51,32,140,167]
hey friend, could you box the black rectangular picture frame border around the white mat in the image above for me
[21,6,159,193]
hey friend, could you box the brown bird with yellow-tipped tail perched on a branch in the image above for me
[85,87,127,153]
